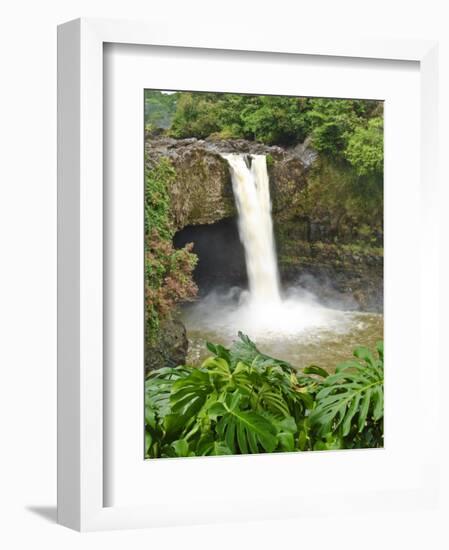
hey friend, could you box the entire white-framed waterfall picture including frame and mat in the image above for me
[58,19,440,530]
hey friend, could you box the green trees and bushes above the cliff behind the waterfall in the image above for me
[164,92,383,172]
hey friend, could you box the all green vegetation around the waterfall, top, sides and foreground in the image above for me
[144,90,384,452]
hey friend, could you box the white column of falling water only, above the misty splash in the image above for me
[223,153,281,304]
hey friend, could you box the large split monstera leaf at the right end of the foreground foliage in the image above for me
[309,344,384,437]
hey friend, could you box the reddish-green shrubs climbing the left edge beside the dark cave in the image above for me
[144,158,197,345]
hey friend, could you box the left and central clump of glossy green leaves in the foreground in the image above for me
[145,334,313,457]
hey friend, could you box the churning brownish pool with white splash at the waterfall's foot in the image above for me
[183,289,383,370]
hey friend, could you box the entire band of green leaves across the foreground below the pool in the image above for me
[145,333,383,458]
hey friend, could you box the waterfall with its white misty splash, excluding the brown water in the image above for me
[183,153,349,344]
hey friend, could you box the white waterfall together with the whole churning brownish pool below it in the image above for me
[179,153,381,366]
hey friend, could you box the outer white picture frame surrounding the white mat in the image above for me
[58,19,440,530]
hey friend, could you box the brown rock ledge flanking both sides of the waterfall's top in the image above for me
[145,136,317,230]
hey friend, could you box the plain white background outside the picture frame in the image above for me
[0,0,449,549]
